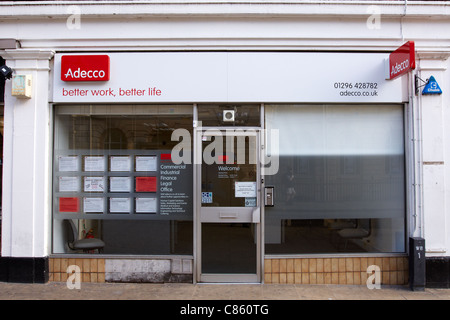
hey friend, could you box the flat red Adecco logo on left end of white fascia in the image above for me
[61,55,109,81]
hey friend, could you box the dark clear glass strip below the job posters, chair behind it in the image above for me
[55,219,193,255]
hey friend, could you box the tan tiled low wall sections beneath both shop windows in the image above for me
[49,256,408,285]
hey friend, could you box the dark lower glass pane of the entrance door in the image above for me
[202,223,256,273]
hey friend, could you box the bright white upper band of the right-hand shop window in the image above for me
[266,105,404,156]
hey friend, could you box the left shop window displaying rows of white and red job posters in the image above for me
[53,105,193,255]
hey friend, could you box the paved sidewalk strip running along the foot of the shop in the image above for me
[0,282,450,302]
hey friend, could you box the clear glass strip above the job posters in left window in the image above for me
[55,115,192,151]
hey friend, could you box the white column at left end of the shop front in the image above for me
[0,49,53,257]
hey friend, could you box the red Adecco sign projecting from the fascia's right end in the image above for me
[388,41,416,80]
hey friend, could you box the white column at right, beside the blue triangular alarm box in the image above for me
[419,53,450,257]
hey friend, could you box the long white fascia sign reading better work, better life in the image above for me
[52,52,404,103]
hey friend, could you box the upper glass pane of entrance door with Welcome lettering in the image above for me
[202,135,257,207]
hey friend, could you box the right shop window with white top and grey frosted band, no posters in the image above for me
[265,105,406,254]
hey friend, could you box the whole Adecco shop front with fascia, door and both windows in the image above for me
[45,52,411,284]
